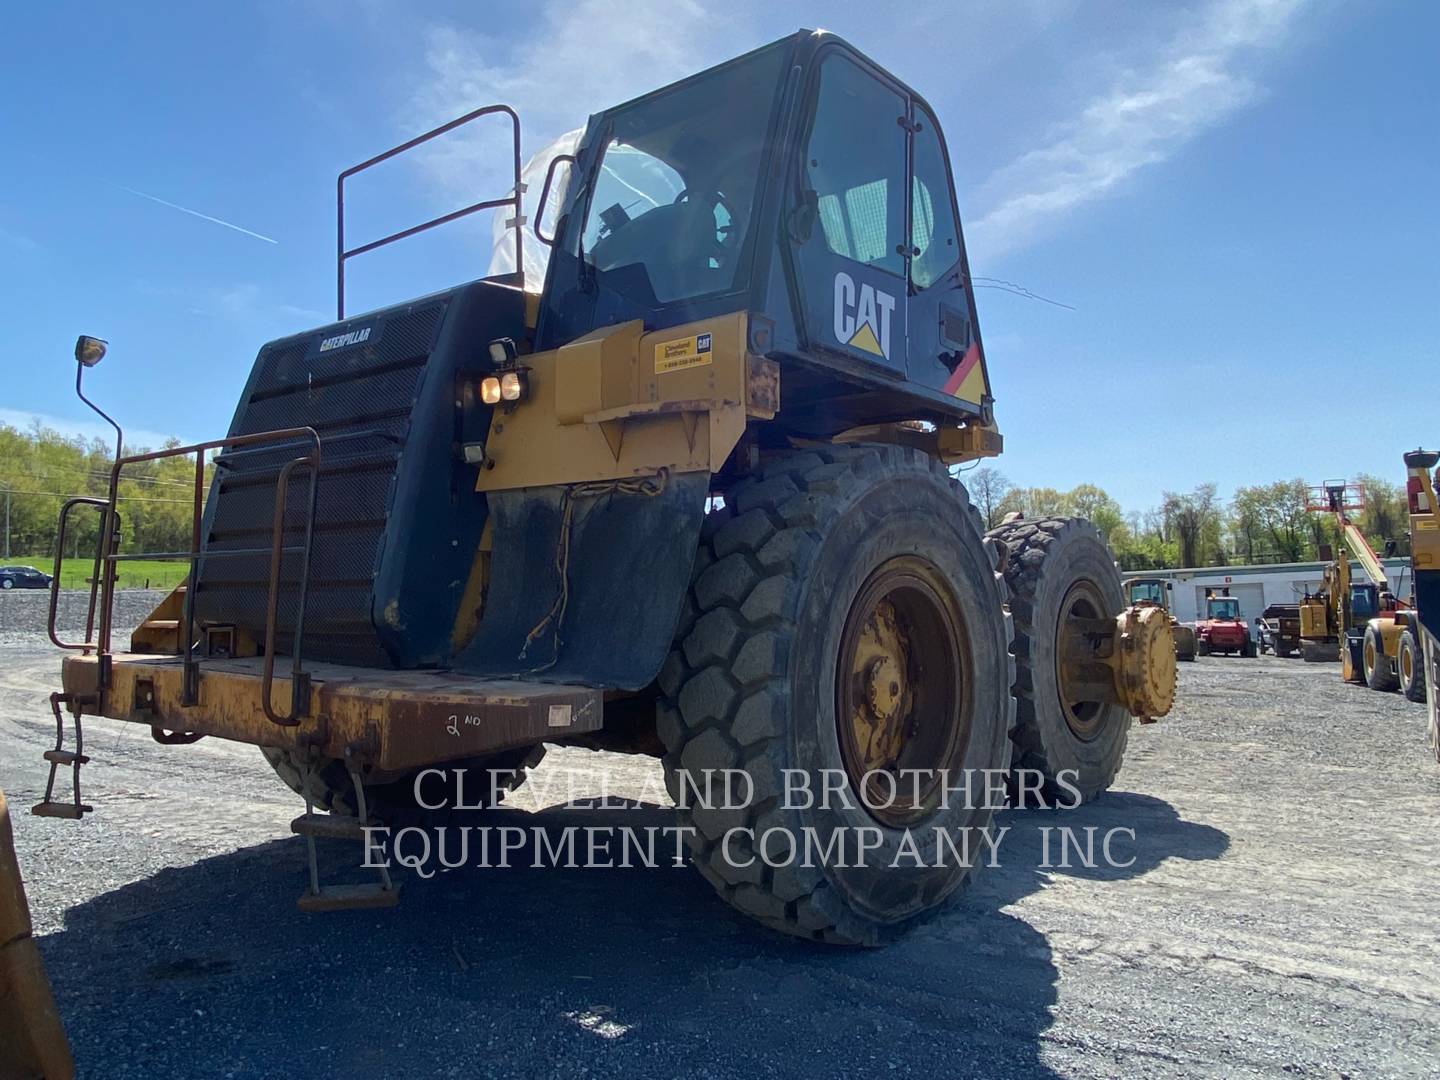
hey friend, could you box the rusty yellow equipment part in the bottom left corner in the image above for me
[0,792,75,1080]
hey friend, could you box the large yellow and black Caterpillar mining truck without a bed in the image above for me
[36,32,1175,943]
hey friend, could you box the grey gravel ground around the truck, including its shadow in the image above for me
[0,595,1440,1077]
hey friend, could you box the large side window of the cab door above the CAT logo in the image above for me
[805,53,904,276]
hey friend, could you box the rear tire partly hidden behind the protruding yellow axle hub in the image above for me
[986,517,1128,801]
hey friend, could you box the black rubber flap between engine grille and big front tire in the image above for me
[454,472,710,690]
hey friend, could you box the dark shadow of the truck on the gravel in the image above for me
[40,792,1228,1077]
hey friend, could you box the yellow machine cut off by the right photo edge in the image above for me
[1400,449,1440,762]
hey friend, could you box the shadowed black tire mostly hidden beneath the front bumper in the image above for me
[261,744,544,828]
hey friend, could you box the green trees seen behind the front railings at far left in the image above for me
[0,423,209,569]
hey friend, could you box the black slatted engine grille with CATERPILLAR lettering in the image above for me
[196,298,449,667]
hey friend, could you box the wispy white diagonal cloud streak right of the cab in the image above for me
[966,0,1308,259]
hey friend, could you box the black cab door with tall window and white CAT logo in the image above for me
[791,48,909,377]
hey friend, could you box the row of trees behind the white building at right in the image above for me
[959,467,1410,570]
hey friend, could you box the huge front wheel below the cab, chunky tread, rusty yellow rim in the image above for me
[658,445,1015,945]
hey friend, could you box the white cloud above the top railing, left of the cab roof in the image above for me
[406,0,749,197]
